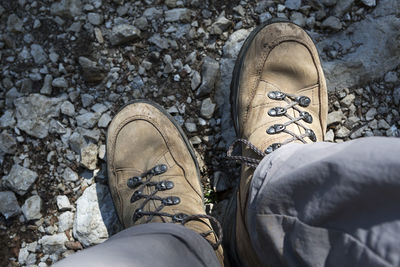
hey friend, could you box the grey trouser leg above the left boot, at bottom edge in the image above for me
[55,223,220,267]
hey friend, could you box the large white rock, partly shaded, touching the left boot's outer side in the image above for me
[73,184,121,247]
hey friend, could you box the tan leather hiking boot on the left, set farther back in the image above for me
[107,101,223,262]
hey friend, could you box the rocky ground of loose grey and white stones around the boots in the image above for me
[0,0,400,266]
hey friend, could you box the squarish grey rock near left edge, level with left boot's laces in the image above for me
[3,164,38,196]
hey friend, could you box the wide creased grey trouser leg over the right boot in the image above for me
[246,137,400,267]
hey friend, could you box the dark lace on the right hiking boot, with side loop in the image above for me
[227,91,317,168]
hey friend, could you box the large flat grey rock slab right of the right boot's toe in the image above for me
[317,0,400,91]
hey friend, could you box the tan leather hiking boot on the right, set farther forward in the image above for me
[224,22,328,266]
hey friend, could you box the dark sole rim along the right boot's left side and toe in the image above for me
[230,18,298,138]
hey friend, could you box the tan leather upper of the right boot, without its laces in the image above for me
[237,23,327,153]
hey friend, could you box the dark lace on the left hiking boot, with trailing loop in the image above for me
[127,164,222,250]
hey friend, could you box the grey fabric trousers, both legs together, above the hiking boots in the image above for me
[57,137,400,267]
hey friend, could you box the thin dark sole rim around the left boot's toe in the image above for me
[106,99,204,200]
